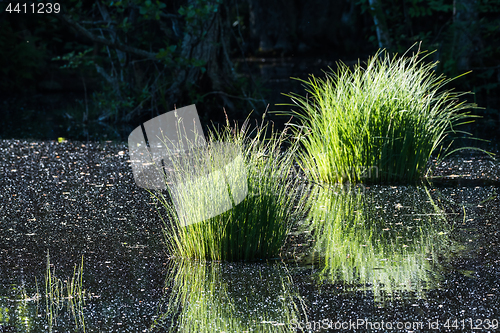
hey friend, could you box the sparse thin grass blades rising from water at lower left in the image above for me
[45,251,85,332]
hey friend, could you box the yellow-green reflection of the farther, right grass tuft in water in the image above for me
[309,187,458,301]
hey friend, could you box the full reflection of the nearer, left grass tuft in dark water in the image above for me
[151,261,307,333]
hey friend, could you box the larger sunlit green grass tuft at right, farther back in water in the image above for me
[286,47,475,183]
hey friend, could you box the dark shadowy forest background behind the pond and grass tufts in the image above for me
[0,0,500,140]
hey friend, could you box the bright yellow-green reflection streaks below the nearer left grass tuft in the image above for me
[151,261,308,333]
